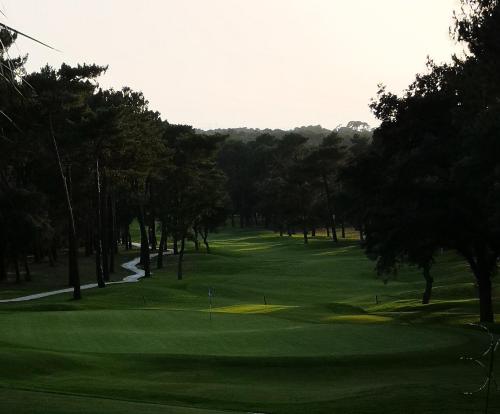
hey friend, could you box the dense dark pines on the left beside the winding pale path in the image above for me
[0,29,227,298]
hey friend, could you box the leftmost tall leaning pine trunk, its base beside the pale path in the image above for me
[49,121,82,300]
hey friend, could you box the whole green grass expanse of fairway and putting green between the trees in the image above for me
[0,231,500,414]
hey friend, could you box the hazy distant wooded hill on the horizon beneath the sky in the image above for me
[196,121,373,145]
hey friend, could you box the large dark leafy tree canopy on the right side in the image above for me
[351,0,500,322]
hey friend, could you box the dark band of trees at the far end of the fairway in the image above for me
[219,131,370,239]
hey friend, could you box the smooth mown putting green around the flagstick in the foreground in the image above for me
[1,310,464,357]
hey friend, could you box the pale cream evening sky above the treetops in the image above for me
[0,0,458,129]
